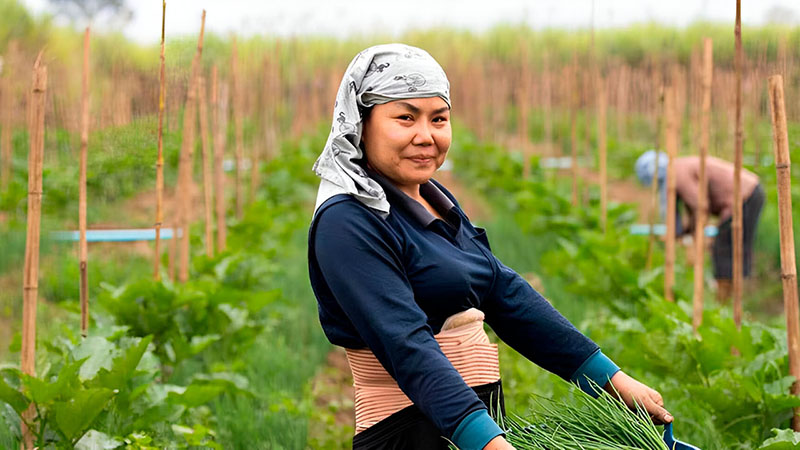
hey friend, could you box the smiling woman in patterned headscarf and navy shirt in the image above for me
[308,44,672,450]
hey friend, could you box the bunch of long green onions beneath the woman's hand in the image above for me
[500,385,668,450]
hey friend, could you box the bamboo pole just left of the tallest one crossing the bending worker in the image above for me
[692,38,714,331]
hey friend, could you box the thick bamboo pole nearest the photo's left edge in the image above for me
[20,52,47,448]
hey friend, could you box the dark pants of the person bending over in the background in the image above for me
[712,184,764,280]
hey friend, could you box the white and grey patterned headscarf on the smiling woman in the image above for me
[314,44,451,216]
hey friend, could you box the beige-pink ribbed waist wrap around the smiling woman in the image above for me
[346,308,500,434]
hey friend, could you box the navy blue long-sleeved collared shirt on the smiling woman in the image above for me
[308,173,618,444]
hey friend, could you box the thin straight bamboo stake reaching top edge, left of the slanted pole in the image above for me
[153,0,169,281]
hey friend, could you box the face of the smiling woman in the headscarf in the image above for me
[362,97,452,197]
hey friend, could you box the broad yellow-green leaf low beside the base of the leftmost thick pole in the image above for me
[52,388,114,441]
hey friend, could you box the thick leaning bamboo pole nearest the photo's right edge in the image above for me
[768,75,800,431]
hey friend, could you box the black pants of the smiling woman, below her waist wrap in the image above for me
[353,380,505,450]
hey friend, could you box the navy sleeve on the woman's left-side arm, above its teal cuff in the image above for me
[311,201,494,437]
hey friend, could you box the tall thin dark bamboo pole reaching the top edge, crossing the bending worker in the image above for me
[732,0,743,328]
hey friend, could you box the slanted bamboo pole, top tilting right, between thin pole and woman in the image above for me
[175,10,206,282]
